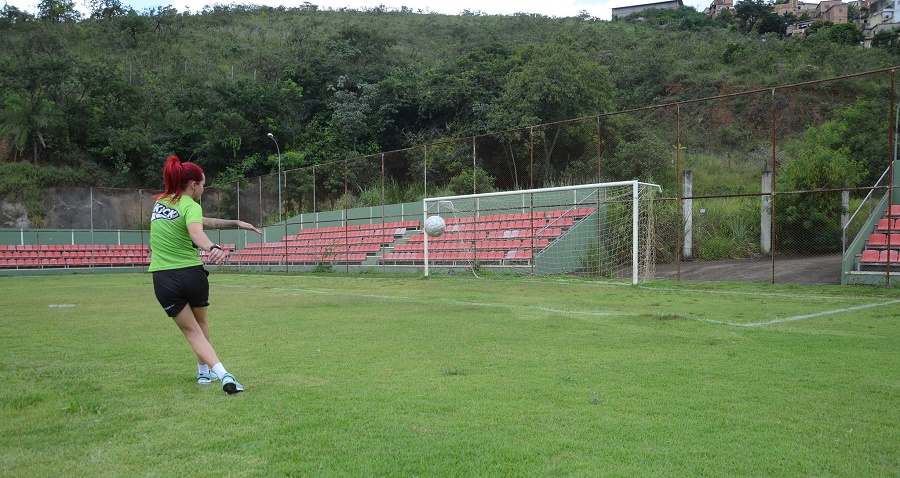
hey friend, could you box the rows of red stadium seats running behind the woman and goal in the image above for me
[0,208,596,269]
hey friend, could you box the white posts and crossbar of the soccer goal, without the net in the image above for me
[422,180,662,284]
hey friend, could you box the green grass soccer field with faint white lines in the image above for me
[0,273,900,477]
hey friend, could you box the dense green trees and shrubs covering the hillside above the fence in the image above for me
[0,0,896,193]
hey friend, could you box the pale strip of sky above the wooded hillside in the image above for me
[0,0,712,20]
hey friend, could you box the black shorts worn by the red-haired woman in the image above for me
[153,266,209,317]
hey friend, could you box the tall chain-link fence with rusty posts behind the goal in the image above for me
[0,69,900,284]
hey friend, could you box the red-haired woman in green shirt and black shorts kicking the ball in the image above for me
[148,156,262,395]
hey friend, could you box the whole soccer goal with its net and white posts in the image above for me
[422,181,660,284]
